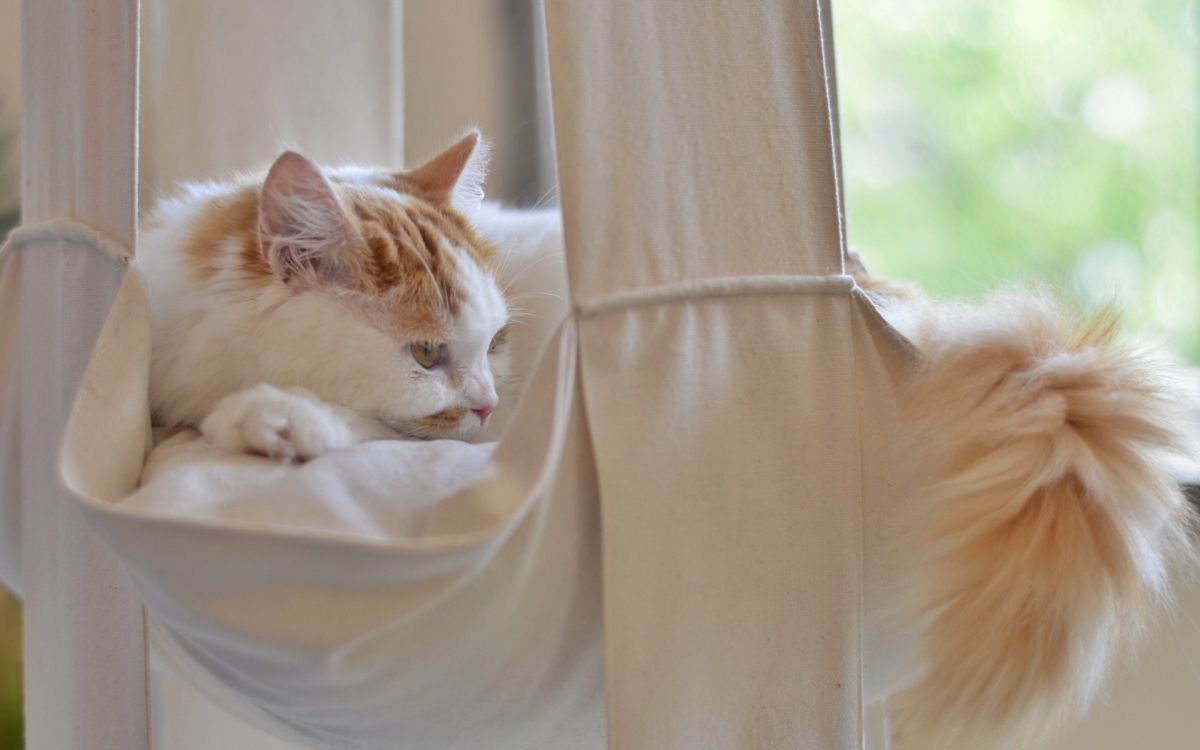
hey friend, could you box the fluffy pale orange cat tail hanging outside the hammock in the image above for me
[889,293,1192,750]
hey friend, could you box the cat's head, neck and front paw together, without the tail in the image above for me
[138,131,510,461]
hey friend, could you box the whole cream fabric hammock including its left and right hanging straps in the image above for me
[0,0,904,750]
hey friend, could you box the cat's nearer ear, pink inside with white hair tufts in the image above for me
[258,151,361,288]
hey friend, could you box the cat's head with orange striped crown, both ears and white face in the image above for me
[257,131,509,438]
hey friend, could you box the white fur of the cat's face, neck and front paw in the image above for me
[138,162,509,458]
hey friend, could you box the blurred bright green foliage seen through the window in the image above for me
[834,0,1200,362]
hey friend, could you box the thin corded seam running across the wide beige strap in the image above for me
[575,274,854,318]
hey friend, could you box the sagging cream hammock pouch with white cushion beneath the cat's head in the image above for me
[64,270,605,750]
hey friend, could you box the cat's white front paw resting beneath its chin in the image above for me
[200,383,355,461]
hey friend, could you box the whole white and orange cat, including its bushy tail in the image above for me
[139,132,1189,750]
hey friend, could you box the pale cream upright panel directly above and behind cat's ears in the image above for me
[140,0,403,201]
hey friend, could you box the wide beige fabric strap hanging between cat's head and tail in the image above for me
[547,0,895,750]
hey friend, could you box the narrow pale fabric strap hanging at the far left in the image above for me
[16,0,149,750]
